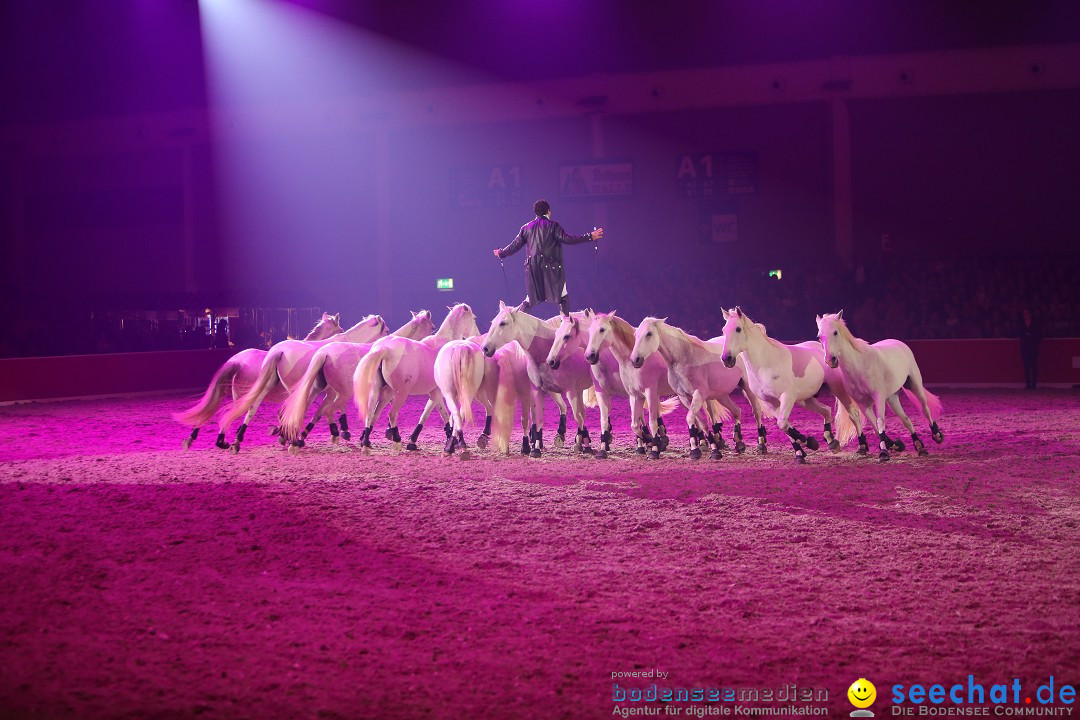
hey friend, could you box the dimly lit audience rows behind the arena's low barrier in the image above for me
[0,255,1080,357]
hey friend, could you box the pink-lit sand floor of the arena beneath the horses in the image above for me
[0,390,1080,719]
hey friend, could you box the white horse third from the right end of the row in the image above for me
[630,317,762,460]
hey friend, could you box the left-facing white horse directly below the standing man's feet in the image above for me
[483,300,593,458]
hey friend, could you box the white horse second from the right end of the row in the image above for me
[724,308,862,463]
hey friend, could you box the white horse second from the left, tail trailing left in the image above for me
[212,315,387,452]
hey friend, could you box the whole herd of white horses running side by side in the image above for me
[175,302,944,463]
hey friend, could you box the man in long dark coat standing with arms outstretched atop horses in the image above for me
[495,200,604,313]
